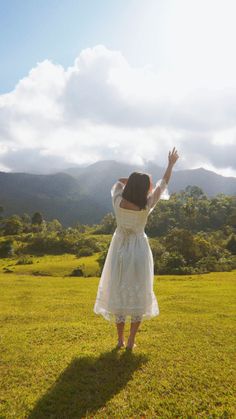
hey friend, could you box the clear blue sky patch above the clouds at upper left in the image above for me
[0,0,127,92]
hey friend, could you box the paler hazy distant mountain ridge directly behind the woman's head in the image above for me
[62,160,236,200]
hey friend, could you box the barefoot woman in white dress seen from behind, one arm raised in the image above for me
[93,147,179,350]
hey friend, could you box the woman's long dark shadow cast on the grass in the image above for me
[28,349,148,419]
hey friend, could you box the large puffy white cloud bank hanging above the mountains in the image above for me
[0,45,236,175]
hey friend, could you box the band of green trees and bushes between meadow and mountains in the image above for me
[0,186,236,275]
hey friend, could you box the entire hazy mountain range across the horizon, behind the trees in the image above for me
[0,160,236,226]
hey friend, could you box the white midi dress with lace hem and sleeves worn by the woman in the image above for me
[93,179,169,323]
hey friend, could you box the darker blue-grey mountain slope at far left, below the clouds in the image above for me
[0,172,106,226]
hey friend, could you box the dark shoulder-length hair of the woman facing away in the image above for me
[122,172,151,209]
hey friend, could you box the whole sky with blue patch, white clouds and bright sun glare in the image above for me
[0,0,236,176]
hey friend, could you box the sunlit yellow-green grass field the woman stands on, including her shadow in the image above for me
[0,270,236,419]
